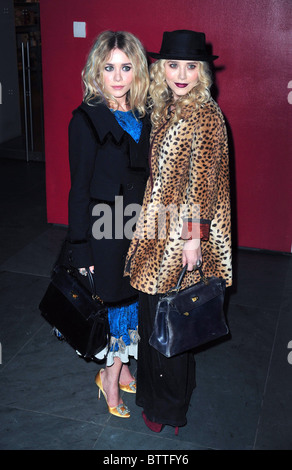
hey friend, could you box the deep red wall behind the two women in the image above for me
[40,0,292,252]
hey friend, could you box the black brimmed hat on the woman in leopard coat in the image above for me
[148,29,218,62]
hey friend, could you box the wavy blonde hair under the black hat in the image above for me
[149,59,212,125]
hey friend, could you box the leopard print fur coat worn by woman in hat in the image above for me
[125,99,232,294]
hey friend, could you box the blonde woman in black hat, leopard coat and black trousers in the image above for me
[125,30,232,432]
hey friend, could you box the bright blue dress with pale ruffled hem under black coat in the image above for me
[96,110,142,366]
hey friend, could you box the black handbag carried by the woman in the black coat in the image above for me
[39,265,110,358]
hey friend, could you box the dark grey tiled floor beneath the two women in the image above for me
[0,159,292,451]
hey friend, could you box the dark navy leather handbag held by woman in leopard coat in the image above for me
[149,266,229,357]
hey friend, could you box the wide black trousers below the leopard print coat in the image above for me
[136,293,195,426]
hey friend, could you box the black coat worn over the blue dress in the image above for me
[66,103,150,302]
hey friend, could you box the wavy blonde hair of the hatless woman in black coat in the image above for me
[81,31,149,117]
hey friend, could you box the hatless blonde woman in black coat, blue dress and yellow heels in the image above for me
[68,31,150,418]
